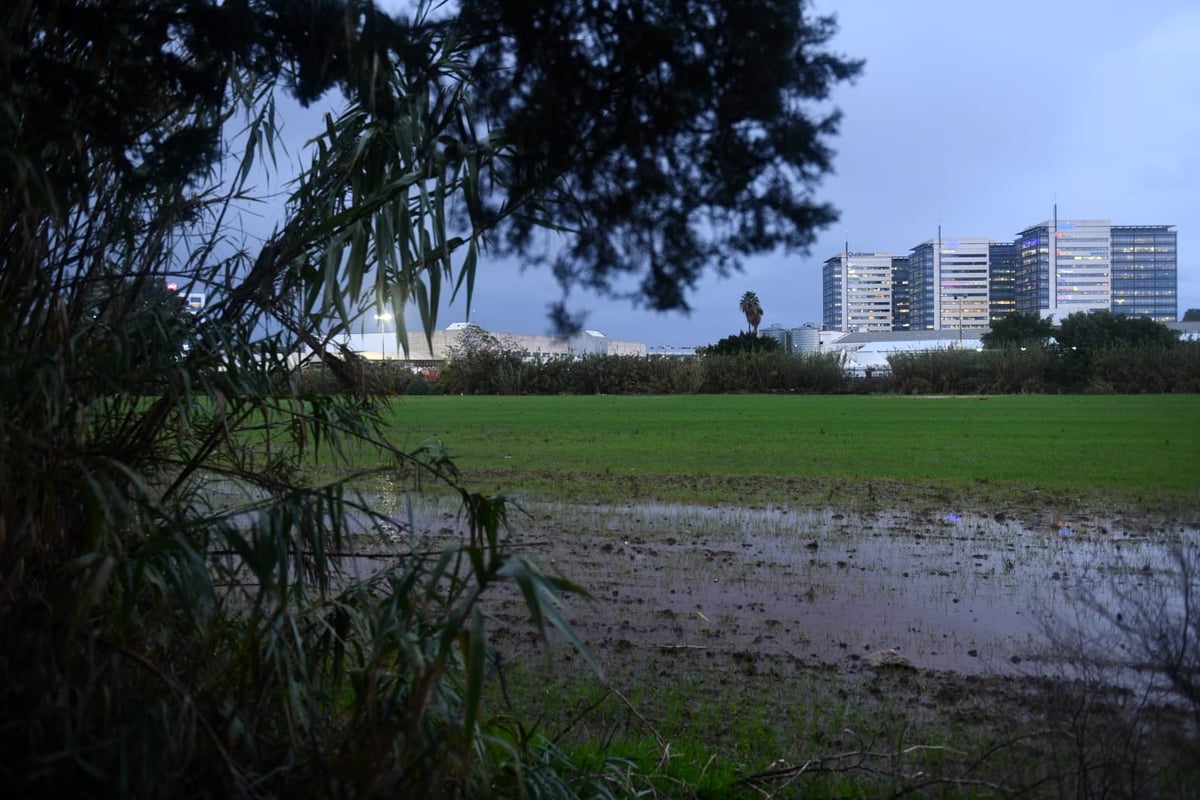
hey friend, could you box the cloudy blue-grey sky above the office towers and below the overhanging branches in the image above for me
[270,0,1200,348]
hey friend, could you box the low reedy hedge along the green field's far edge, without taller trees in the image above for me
[301,342,1200,395]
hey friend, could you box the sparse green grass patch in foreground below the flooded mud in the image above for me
[482,654,1045,800]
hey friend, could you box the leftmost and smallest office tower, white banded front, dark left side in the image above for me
[822,249,892,332]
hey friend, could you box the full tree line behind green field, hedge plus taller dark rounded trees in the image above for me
[305,312,1200,395]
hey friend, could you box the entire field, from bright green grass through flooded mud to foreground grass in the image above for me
[361,395,1200,798]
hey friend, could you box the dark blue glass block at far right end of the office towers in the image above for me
[1110,225,1178,323]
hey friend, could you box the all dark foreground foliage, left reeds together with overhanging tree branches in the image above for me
[0,0,857,796]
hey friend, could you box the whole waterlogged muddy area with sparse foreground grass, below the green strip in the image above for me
[350,491,1200,796]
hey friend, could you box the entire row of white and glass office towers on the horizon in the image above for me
[822,210,1178,332]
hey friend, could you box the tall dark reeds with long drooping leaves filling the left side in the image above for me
[0,0,609,798]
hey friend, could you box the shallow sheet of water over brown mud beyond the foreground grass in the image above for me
[345,496,1200,674]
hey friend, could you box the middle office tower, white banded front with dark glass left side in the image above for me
[908,234,992,331]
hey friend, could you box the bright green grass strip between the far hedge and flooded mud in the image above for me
[364,395,1200,510]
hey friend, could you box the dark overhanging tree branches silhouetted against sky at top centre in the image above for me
[461,0,862,319]
